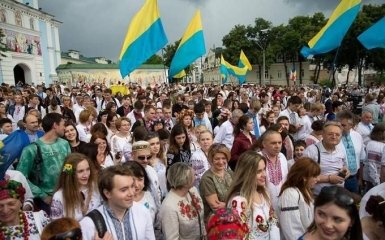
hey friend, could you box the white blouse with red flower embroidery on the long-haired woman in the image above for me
[228,196,280,240]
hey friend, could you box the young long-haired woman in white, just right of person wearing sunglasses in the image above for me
[145,132,167,199]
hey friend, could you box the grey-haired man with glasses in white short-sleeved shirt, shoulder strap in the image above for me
[303,121,350,195]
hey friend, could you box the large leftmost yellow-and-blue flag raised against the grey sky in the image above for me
[119,0,168,78]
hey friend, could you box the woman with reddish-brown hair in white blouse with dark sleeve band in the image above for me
[277,157,321,240]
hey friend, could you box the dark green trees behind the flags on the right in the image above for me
[222,4,385,84]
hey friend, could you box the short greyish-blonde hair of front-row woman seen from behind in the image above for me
[167,162,194,189]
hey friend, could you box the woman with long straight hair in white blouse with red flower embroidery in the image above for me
[226,151,280,240]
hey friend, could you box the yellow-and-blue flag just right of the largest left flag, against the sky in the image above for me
[168,10,206,78]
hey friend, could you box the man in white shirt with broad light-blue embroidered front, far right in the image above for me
[337,111,366,193]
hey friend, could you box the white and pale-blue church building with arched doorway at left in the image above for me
[0,0,61,85]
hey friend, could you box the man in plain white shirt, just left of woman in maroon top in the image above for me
[214,109,243,149]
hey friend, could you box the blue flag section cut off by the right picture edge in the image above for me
[358,17,385,49]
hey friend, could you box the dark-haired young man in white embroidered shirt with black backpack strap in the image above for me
[80,166,155,240]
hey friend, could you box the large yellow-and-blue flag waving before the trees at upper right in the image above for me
[301,0,361,58]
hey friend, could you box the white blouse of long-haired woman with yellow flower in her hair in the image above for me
[51,189,102,221]
